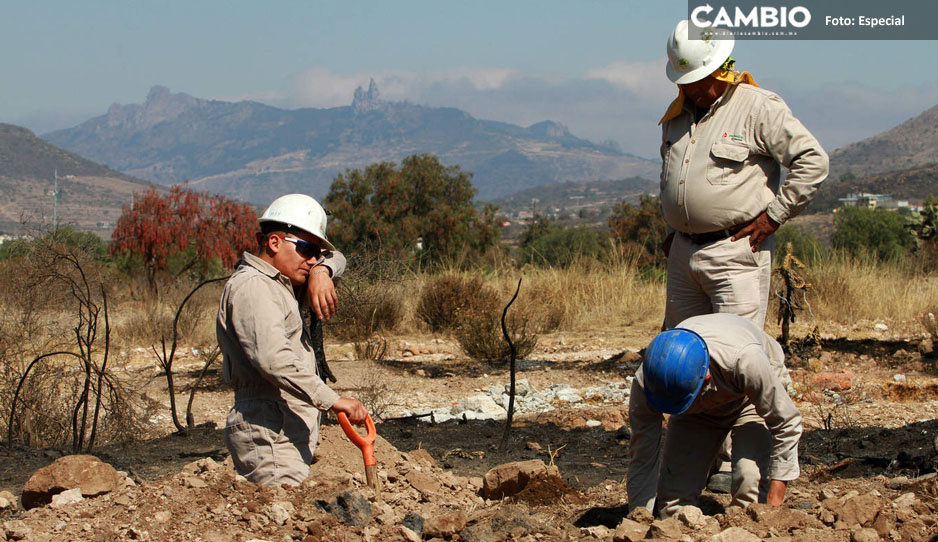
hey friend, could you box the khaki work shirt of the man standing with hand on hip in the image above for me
[661,84,828,233]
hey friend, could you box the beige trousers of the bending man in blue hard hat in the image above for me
[657,404,772,518]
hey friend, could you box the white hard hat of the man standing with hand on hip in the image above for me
[666,20,736,85]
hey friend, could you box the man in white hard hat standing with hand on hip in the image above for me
[660,21,829,492]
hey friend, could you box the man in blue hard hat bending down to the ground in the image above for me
[627,313,802,518]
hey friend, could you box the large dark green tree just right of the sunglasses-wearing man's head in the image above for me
[325,154,500,262]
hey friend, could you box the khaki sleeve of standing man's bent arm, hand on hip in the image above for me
[754,95,830,224]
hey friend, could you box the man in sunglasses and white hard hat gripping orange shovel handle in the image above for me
[215,194,368,486]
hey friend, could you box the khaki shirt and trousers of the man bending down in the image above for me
[627,314,802,518]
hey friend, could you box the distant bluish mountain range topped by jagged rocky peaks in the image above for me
[45,84,660,204]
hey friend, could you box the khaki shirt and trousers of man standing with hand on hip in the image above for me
[661,84,828,328]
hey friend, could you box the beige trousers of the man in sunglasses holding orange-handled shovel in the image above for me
[225,398,319,486]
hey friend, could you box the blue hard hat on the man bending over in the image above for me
[642,328,710,414]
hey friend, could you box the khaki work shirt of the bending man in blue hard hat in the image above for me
[627,313,802,506]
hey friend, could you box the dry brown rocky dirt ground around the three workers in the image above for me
[0,329,938,541]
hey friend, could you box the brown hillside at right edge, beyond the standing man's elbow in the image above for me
[830,105,938,183]
